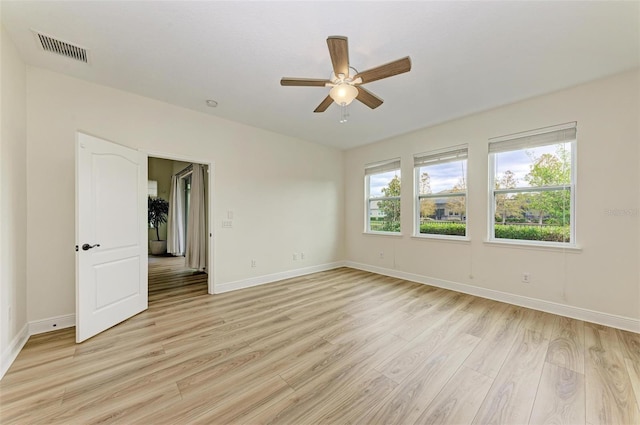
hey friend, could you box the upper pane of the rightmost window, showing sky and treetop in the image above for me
[494,142,571,189]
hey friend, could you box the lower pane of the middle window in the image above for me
[420,196,467,236]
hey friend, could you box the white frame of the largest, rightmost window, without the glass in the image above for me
[486,122,579,249]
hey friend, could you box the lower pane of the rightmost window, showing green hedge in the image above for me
[494,190,571,242]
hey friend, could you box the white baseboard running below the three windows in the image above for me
[344,261,640,333]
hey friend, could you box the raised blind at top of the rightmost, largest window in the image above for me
[489,122,577,153]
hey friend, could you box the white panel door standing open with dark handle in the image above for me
[76,133,148,342]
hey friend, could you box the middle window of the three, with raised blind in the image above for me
[414,146,467,237]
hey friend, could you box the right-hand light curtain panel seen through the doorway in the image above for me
[185,164,207,271]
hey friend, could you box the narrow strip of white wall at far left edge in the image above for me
[0,28,27,376]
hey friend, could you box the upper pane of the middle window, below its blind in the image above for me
[418,159,467,195]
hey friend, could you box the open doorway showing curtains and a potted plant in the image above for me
[148,156,212,298]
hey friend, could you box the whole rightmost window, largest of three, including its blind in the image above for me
[489,123,576,245]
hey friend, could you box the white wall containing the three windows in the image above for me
[345,70,640,322]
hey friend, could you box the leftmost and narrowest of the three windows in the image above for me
[365,159,400,233]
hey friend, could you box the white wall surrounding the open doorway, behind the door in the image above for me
[27,66,344,321]
